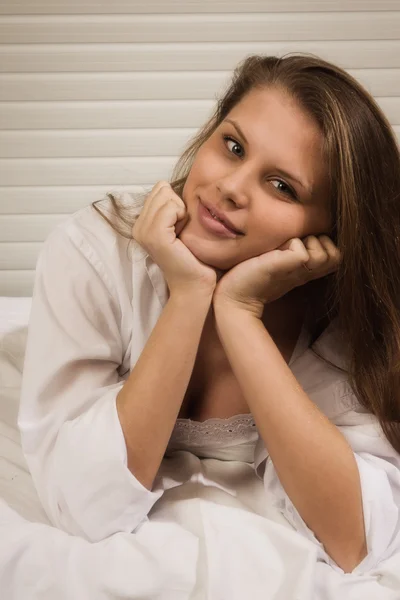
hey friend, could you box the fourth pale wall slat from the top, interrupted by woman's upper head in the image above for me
[0,69,400,101]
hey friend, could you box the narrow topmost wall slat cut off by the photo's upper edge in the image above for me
[0,0,399,15]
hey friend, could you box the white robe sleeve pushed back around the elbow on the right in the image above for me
[254,409,400,574]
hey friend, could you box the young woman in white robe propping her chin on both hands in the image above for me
[19,55,400,572]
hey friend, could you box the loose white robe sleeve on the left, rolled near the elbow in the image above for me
[18,227,163,542]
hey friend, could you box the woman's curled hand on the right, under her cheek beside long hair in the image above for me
[213,235,340,318]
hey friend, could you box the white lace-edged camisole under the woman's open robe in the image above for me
[165,323,309,463]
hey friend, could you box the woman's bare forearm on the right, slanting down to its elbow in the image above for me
[214,305,366,572]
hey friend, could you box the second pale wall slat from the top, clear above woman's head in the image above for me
[0,12,400,44]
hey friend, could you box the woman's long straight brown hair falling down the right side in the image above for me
[93,54,400,452]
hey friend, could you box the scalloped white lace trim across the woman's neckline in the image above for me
[169,414,258,446]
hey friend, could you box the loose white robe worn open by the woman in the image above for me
[18,194,400,597]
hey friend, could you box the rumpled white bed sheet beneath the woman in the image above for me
[0,298,400,600]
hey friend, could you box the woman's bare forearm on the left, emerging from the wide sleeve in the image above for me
[117,292,212,490]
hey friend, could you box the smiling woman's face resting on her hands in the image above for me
[179,88,331,270]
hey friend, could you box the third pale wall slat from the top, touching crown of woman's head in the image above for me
[0,40,400,73]
